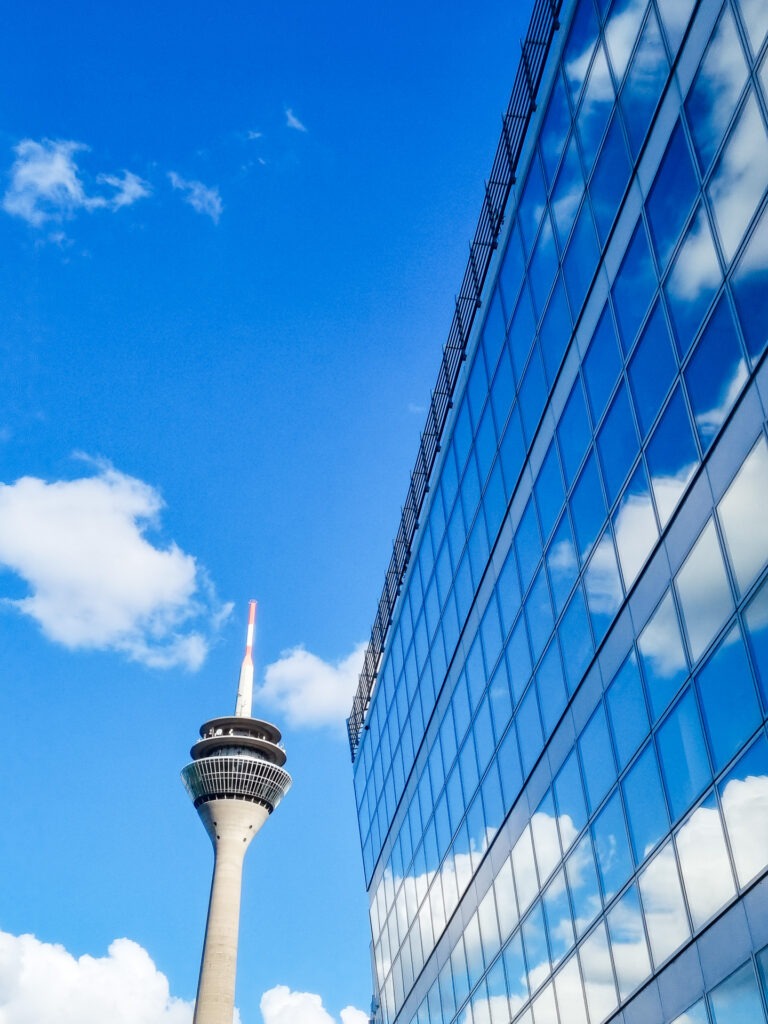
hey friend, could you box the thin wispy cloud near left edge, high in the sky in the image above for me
[2,138,150,227]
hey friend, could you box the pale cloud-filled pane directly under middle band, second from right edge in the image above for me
[676,519,733,662]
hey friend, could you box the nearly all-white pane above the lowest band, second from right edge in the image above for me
[677,794,736,929]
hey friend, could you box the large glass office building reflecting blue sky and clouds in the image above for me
[349,0,768,1024]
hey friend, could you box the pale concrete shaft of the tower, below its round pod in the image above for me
[194,800,269,1024]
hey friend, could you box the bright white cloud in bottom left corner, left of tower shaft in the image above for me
[0,932,193,1024]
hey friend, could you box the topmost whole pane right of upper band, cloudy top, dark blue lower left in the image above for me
[685,7,746,172]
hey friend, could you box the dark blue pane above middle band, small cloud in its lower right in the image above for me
[685,295,748,452]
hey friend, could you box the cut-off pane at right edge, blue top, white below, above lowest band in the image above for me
[719,734,768,887]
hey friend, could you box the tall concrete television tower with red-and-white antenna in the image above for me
[181,601,291,1024]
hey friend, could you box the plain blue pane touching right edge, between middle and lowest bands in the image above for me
[696,626,762,771]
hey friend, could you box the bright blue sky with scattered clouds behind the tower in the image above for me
[0,0,528,1024]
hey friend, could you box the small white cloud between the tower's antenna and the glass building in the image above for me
[257,643,367,728]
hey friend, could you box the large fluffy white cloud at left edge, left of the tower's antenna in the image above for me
[0,463,231,670]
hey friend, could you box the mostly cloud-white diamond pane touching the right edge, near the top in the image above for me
[707,93,768,262]
